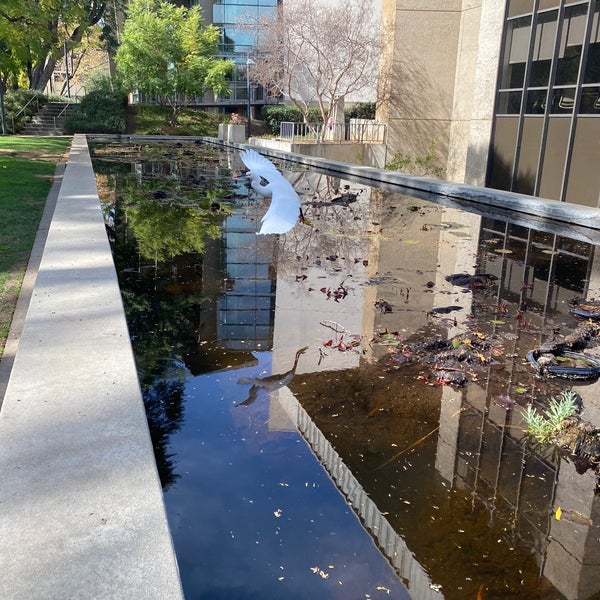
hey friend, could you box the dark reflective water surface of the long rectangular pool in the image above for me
[92,144,600,600]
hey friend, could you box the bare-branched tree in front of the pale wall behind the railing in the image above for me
[242,0,380,136]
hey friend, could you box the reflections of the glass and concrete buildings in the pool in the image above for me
[113,149,600,600]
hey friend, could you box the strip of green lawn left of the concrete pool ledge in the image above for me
[0,136,71,357]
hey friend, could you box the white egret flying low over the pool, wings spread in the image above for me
[240,150,302,234]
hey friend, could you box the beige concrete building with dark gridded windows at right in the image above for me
[378,0,600,207]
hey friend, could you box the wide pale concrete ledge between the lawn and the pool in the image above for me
[0,135,183,600]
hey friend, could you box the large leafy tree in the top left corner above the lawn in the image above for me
[0,0,115,90]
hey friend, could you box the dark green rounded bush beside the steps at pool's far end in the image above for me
[65,90,126,134]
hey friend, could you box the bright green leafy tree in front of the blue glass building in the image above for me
[115,0,234,125]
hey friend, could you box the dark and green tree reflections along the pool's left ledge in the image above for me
[94,143,237,489]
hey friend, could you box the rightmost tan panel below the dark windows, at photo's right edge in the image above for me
[566,117,600,208]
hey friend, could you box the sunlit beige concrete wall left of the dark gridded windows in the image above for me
[377,0,505,185]
